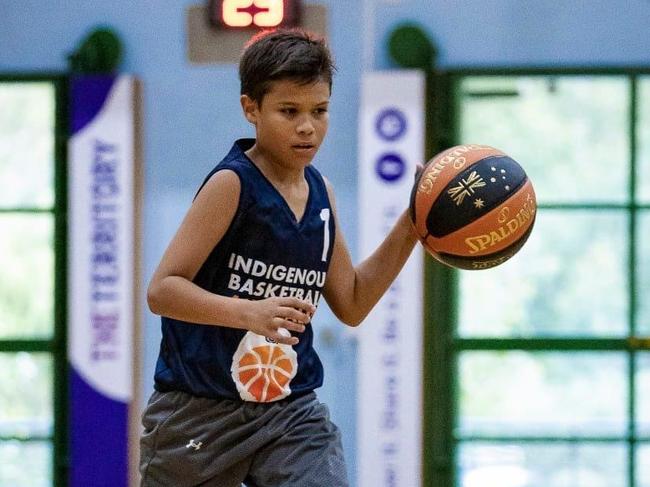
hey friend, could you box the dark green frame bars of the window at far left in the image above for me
[0,73,69,487]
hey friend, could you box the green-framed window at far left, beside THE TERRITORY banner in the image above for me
[0,76,67,487]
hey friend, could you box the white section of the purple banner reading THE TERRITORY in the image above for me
[68,76,135,403]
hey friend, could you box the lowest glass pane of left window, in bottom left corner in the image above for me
[0,441,52,487]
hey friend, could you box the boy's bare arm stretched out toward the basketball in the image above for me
[323,179,418,326]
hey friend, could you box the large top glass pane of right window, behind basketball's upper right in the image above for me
[460,76,629,203]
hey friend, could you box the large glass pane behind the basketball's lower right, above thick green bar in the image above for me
[459,210,628,337]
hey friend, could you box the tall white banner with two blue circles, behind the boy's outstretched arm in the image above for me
[357,71,425,487]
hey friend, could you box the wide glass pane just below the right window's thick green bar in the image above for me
[458,352,628,438]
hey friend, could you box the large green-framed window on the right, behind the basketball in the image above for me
[428,71,650,487]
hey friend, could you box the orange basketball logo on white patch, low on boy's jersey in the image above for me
[230,331,298,402]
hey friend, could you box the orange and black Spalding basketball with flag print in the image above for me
[409,144,537,270]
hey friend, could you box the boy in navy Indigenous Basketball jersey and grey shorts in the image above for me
[140,30,417,487]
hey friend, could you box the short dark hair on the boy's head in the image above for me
[239,29,336,104]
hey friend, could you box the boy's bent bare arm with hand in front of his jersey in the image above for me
[147,170,315,345]
